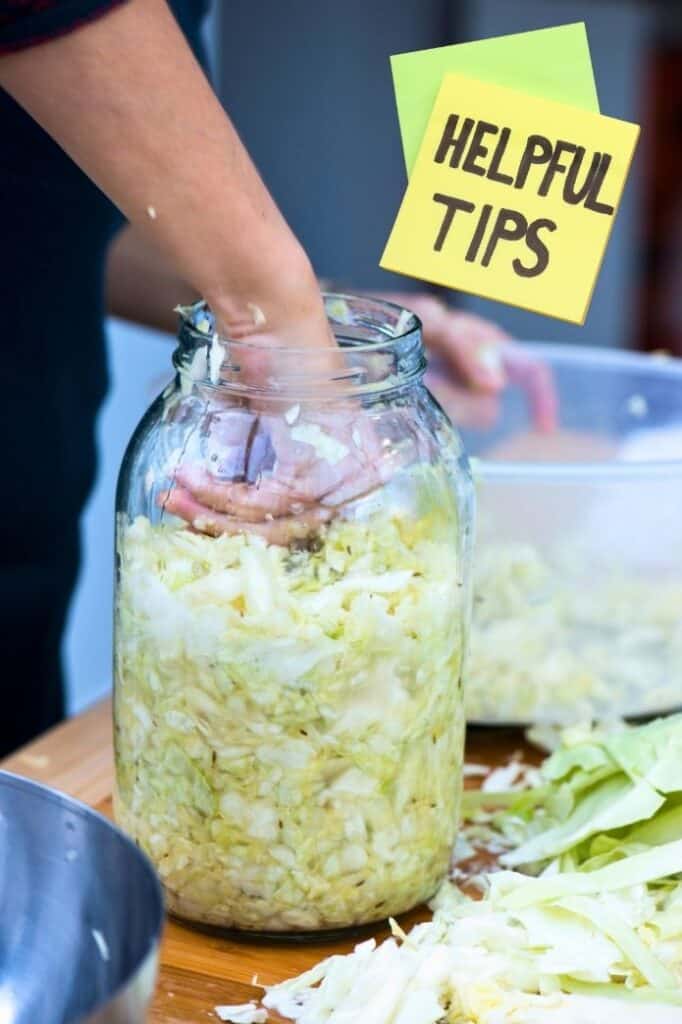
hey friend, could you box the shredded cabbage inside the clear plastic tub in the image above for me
[466,541,682,724]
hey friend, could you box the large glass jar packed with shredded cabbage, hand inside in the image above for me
[115,296,473,933]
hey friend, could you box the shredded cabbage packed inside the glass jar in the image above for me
[115,509,464,931]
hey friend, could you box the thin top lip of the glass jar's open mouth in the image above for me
[175,292,422,356]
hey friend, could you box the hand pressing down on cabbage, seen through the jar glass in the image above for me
[159,407,407,545]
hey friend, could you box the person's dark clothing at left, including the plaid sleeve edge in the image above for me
[0,0,208,756]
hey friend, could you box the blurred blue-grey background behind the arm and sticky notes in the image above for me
[65,0,682,713]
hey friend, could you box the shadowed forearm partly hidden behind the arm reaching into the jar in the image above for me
[106,224,200,333]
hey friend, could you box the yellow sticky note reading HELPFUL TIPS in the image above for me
[381,75,639,324]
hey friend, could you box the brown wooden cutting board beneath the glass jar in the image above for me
[0,700,538,1024]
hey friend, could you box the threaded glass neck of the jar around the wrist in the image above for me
[173,293,426,398]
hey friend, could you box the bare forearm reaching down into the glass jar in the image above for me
[0,0,315,341]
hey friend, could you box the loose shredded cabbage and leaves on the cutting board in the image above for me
[254,716,682,1024]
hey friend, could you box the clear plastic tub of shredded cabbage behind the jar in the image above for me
[454,345,682,723]
